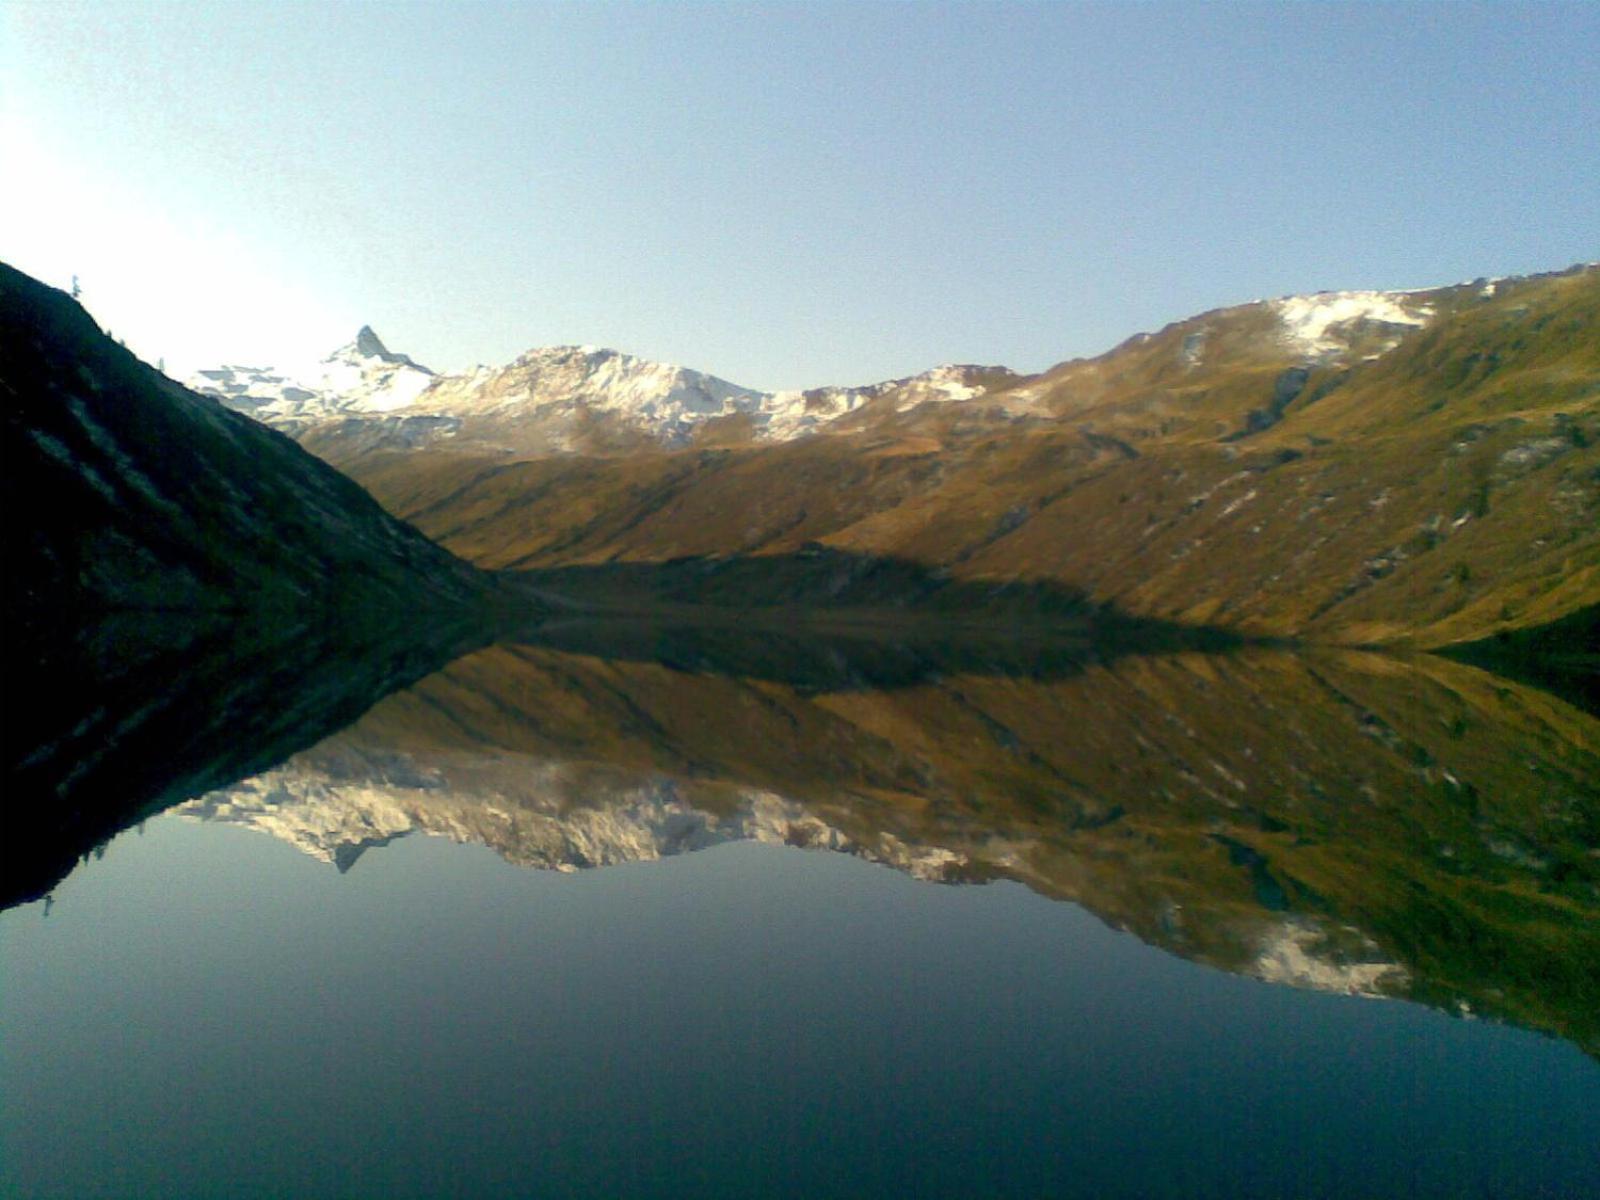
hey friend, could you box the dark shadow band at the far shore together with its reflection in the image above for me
[501,547,1248,693]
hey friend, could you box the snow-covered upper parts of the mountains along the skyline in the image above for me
[187,282,1452,453]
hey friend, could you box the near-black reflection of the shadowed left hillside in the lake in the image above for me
[0,610,488,907]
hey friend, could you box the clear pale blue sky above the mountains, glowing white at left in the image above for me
[0,0,1600,387]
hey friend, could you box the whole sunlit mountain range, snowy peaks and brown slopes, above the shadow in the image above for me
[197,266,1600,666]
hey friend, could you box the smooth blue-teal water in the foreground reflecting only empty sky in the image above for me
[12,816,1600,1197]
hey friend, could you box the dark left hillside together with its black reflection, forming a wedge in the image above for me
[0,266,518,901]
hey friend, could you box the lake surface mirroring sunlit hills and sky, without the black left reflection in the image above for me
[0,624,1600,1197]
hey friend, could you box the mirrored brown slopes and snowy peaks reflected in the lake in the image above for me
[162,622,1600,1054]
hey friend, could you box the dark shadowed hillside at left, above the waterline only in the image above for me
[0,264,486,618]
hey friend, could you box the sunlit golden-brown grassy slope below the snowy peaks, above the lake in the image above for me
[318,267,1600,645]
